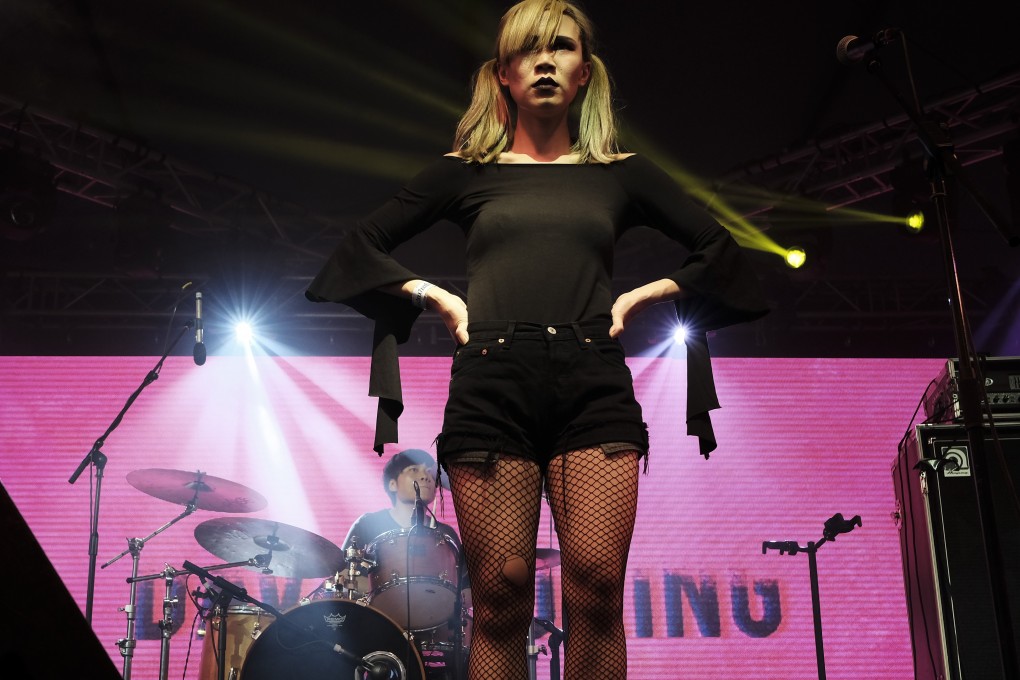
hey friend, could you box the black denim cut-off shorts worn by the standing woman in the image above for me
[437,321,648,471]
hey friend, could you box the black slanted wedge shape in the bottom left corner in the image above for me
[0,484,120,680]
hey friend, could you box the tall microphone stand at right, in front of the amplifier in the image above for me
[836,30,1020,678]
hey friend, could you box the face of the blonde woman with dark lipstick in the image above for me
[499,15,592,117]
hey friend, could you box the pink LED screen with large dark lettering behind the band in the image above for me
[0,356,944,680]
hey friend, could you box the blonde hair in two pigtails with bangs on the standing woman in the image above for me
[453,0,617,163]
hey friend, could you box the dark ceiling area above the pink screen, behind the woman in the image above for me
[0,0,1020,357]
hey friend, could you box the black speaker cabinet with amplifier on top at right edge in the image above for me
[893,422,1020,680]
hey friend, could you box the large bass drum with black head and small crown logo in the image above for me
[241,599,425,680]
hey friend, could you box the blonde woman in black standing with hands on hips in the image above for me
[307,0,766,680]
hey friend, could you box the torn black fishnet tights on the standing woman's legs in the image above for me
[449,448,639,680]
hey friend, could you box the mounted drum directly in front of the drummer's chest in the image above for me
[368,526,458,630]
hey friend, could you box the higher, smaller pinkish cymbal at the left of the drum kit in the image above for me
[128,468,269,513]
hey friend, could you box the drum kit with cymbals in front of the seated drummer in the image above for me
[103,469,559,680]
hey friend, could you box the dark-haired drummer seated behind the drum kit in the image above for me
[343,449,469,606]
